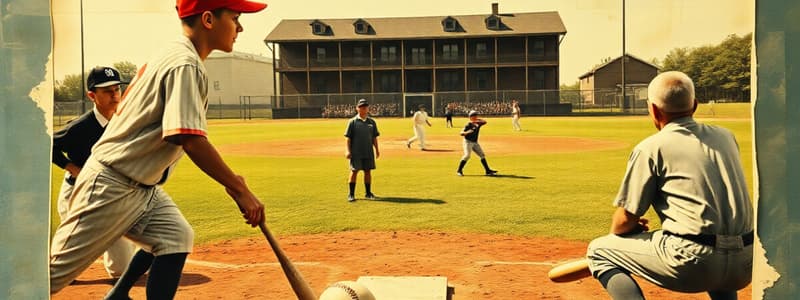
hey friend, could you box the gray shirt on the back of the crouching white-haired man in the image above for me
[614,117,753,235]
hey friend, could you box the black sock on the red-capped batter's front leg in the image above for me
[147,253,189,300]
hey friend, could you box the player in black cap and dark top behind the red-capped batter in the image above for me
[53,67,136,278]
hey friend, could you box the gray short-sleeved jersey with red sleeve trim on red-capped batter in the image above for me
[92,36,208,185]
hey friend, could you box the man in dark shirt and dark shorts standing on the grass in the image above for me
[344,99,381,202]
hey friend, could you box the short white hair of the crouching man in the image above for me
[647,71,694,112]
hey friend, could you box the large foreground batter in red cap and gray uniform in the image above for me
[50,0,266,299]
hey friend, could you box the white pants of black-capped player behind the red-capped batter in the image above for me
[57,172,137,278]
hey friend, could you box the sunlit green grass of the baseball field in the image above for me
[52,103,753,243]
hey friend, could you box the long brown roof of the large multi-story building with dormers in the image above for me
[264,11,567,42]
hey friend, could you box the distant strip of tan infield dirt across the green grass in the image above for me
[219,136,627,157]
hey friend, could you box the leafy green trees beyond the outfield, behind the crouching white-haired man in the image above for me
[561,33,753,102]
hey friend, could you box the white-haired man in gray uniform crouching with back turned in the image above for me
[587,71,753,299]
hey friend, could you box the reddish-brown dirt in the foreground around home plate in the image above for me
[52,231,751,299]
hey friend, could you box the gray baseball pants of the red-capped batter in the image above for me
[50,159,194,293]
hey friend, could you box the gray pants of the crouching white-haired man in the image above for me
[587,230,753,293]
